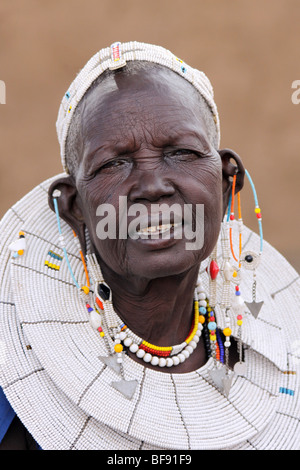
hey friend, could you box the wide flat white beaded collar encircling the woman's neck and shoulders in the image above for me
[0,174,299,449]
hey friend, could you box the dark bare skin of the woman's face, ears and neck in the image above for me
[49,69,244,373]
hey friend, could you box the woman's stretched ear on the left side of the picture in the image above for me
[48,176,86,254]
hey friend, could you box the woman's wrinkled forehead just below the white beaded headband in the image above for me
[81,66,209,136]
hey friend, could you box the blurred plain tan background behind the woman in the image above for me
[0,0,300,271]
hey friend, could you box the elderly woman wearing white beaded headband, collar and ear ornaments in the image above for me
[0,43,300,450]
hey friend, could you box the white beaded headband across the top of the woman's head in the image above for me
[56,42,220,172]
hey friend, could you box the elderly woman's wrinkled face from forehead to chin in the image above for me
[76,69,222,279]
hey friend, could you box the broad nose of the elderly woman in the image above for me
[128,168,175,202]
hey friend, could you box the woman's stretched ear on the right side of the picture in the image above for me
[218,149,245,216]
